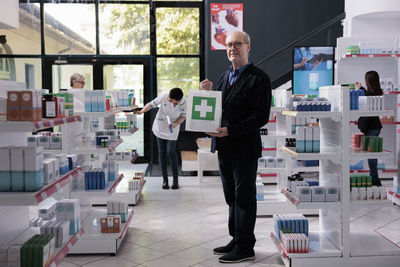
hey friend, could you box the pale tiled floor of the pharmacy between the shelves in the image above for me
[60,177,400,267]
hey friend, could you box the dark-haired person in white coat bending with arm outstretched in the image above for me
[136,88,186,189]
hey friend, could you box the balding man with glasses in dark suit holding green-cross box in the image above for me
[200,31,271,263]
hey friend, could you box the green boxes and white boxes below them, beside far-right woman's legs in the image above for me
[350,174,387,200]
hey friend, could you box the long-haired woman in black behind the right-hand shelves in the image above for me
[356,71,383,186]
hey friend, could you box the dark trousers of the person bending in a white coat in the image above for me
[157,137,178,177]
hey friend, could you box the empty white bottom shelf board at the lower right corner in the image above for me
[350,231,400,258]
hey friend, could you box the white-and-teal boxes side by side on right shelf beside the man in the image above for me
[296,127,321,153]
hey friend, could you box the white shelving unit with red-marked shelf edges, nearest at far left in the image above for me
[0,116,85,267]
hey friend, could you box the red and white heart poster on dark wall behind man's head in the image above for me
[211,3,243,50]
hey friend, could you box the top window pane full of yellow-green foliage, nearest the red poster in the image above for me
[156,8,200,55]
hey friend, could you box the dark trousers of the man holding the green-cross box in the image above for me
[218,151,257,250]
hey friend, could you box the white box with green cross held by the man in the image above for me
[186,90,222,133]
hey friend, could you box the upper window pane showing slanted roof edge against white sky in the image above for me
[44,4,96,55]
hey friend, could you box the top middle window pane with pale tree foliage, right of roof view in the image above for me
[99,4,150,55]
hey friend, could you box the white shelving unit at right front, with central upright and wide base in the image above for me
[271,85,400,267]
